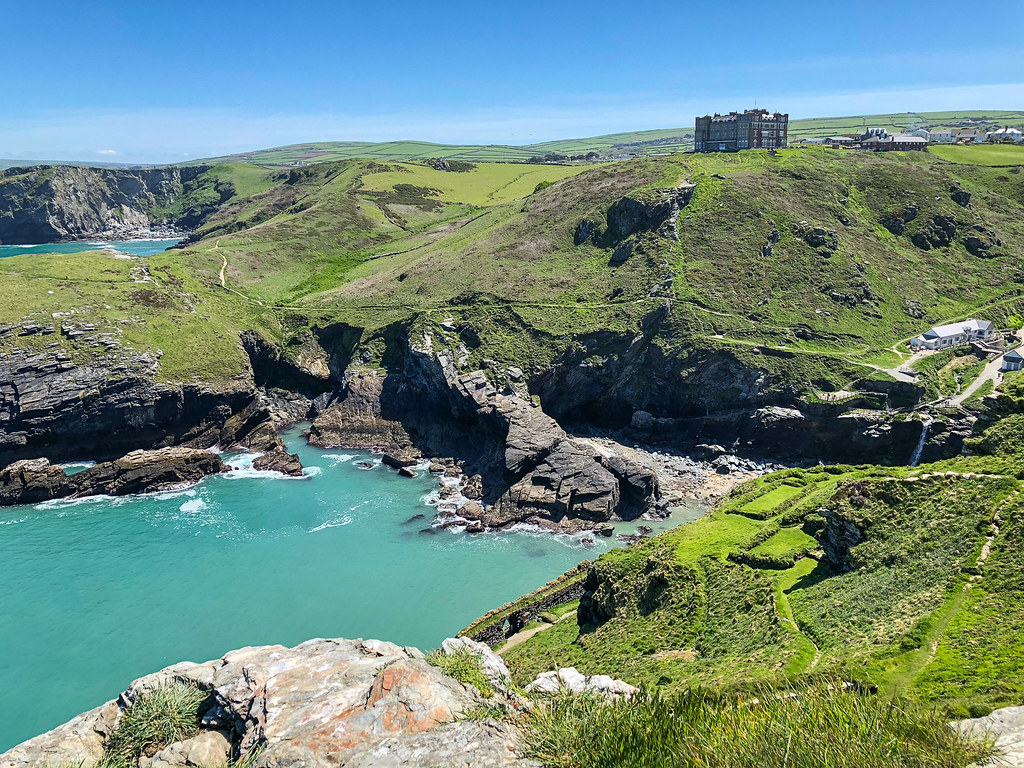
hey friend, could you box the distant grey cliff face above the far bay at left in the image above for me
[0,166,222,245]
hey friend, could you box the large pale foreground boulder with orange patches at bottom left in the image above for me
[0,639,537,768]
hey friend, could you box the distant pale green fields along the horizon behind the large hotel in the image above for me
[190,110,1024,166]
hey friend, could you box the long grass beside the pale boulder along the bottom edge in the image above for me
[527,684,992,768]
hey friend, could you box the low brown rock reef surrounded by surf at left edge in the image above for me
[0,447,224,505]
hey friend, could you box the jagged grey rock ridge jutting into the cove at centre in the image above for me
[309,336,660,529]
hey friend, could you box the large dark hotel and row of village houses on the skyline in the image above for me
[693,110,1024,152]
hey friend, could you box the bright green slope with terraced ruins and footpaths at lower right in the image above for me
[485,405,1024,716]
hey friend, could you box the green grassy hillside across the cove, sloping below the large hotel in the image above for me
[8,150,1024,403]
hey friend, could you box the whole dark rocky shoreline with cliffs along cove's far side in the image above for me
[0,319,970,535]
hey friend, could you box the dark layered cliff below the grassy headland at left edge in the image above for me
[0,339,281,464]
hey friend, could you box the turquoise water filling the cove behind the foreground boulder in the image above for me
[0,430,696,752]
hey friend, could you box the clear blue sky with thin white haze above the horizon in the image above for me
[0,0,1024,162]
